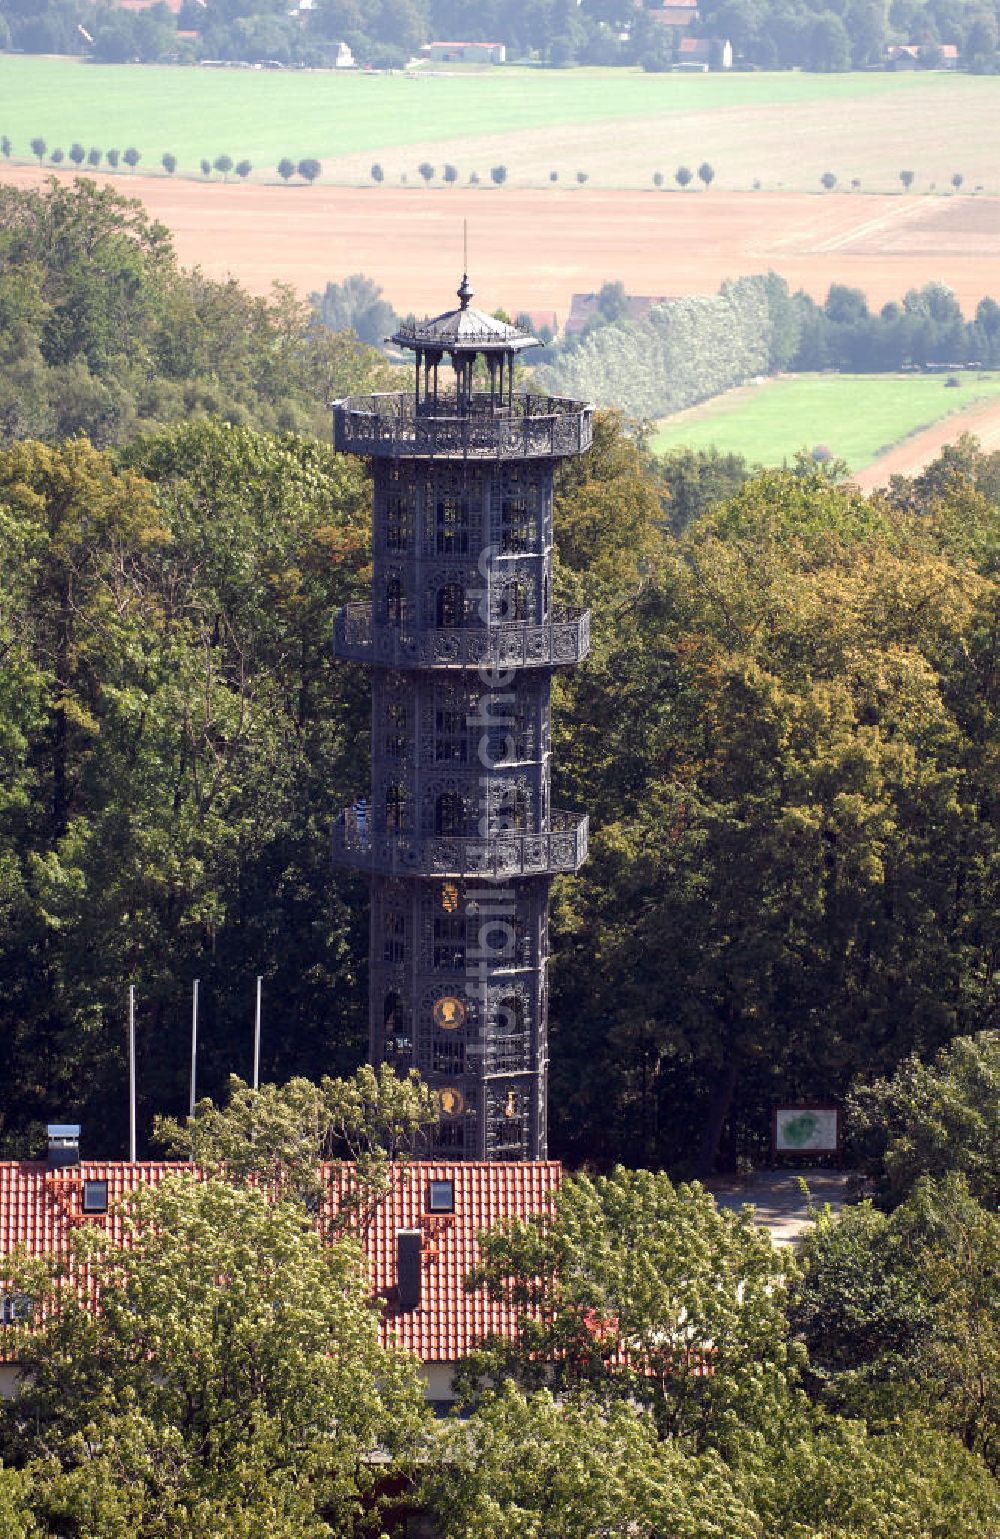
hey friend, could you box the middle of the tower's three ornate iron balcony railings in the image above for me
[334,603,591,668]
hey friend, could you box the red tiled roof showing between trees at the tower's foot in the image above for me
[0,1160,562,1362]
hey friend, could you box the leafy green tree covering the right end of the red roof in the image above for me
[458,1170,798,1454]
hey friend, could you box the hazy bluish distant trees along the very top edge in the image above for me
[0,0,997,72]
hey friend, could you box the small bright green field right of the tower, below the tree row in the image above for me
[652,374,1000,471]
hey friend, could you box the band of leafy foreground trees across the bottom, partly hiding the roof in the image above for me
[0,1033,1000,1539]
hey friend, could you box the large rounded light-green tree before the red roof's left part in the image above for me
[0,1176,425,1539]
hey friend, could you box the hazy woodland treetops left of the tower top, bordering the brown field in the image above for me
[0,179,392,446]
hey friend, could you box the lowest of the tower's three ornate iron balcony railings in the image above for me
[332,810,589,877]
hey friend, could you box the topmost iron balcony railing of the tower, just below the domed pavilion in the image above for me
[334,391,594,460]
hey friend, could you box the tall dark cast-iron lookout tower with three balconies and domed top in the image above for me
[332,277,591,1159]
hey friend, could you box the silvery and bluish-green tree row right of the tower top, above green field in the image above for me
[535,272,1000,417]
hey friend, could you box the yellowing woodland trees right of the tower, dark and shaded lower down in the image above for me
[552,451,997,1170]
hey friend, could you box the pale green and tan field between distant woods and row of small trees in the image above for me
[0,54,1000,195]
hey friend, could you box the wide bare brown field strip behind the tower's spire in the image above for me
[2,168,1000,322]
